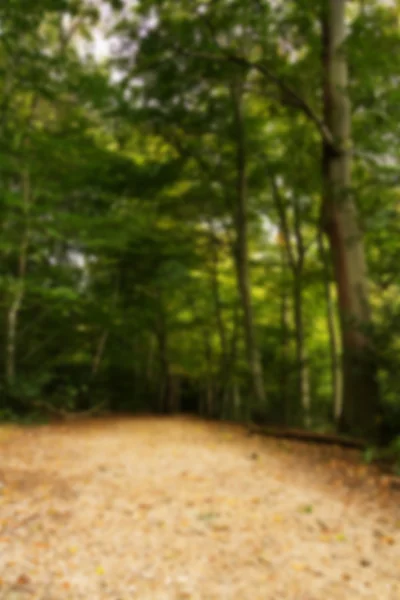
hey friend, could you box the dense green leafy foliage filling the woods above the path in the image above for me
[0,0,400,440]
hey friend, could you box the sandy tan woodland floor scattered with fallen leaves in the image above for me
[0,418,400,600]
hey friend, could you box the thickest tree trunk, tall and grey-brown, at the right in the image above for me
[323,0,379,437]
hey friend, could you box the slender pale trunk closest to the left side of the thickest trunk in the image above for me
[318,231,343,424]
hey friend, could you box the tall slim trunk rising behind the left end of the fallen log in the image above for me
[231,83,266,409]
